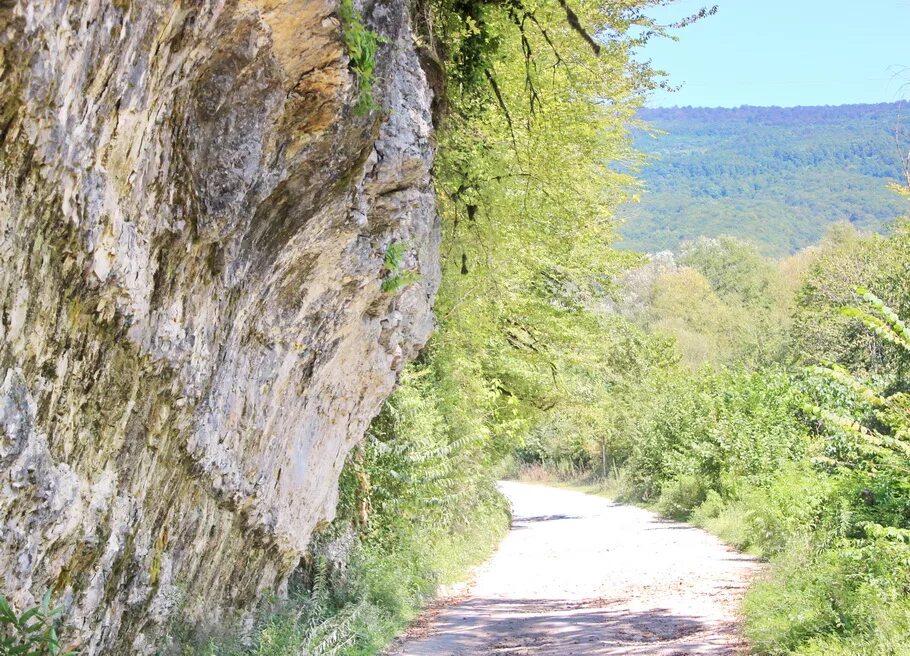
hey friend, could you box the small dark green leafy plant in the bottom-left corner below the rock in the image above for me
[0,593,76,656]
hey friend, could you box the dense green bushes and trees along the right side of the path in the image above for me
[513,224,910,656]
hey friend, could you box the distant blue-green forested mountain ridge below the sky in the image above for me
[618,103,910,255]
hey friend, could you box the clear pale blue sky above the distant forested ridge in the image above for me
[639,0,910,107]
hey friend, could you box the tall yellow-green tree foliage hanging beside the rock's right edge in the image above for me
[410,0,696,528]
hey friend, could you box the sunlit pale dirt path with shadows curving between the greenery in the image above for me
[389,482,758,656]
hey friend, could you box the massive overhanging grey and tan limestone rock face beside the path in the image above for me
[0,0,439,656]
